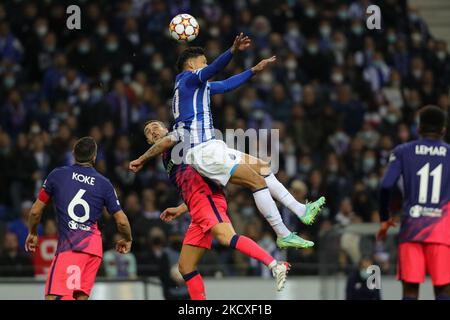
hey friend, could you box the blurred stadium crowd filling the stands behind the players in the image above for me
[0,0,450,283]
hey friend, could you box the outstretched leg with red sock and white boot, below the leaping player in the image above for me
[211,223,290,291]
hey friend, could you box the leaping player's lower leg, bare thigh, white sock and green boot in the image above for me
[230,159,314,249]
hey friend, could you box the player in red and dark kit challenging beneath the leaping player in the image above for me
[136,122,289,300]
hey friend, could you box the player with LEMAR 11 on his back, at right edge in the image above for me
[378,106,450,300]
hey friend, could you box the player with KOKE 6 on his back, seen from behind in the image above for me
[25,137,132,300]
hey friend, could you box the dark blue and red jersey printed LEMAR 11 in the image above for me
[381,139,450,245]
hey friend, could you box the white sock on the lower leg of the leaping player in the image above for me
[253,188,291,238]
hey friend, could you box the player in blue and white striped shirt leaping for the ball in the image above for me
[130,33,325,249]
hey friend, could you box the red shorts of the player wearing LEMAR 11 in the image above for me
[397,242,450,286]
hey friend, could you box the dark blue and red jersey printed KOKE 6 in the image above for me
[39,164,121,257]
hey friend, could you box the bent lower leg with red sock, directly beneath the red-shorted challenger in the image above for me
[178,244,206,300]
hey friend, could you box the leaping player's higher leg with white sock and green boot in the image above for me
[242,154,325,225]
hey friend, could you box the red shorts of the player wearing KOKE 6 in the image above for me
[45,251,102,299]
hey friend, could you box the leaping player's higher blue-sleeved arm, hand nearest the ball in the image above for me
[194,32,251,82]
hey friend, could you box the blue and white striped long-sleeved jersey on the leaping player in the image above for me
[172,50,253,147]
